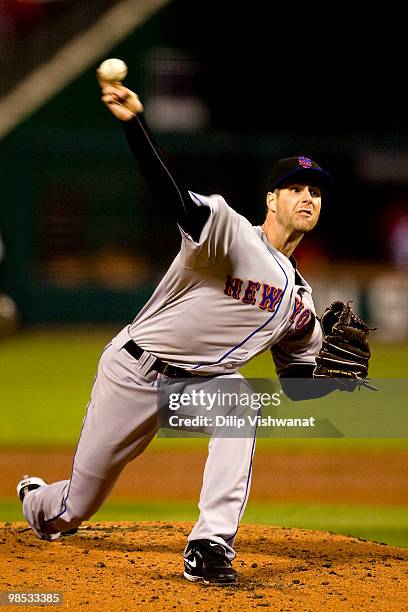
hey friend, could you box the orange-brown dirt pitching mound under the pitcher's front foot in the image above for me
[0,522,408,612]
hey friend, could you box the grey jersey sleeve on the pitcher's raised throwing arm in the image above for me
[179,191,240,268]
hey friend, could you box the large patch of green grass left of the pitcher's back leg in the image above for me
[0,330,110,446]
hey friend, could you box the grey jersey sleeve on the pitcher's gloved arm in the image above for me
[271,316,323,376]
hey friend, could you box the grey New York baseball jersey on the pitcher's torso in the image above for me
[129,192,322,374]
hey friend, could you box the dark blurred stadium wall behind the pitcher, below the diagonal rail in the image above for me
[0,0,408,321]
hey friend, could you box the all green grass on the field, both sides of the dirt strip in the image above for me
[0,328,408,547]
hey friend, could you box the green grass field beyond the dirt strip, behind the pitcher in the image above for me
[0,328,408,450]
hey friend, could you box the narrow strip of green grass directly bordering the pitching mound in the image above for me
[0,500,408,548]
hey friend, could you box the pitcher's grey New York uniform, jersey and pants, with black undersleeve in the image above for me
[23,117,322,559]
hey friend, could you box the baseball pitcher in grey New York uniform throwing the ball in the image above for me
[17,82,369,584]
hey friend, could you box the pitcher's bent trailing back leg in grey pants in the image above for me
[23,347,157,538]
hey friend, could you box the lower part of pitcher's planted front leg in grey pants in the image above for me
[188,435,255,559]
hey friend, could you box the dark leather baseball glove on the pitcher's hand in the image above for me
[313,302,376,391]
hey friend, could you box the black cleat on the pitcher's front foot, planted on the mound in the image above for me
[183,540,238,585]
